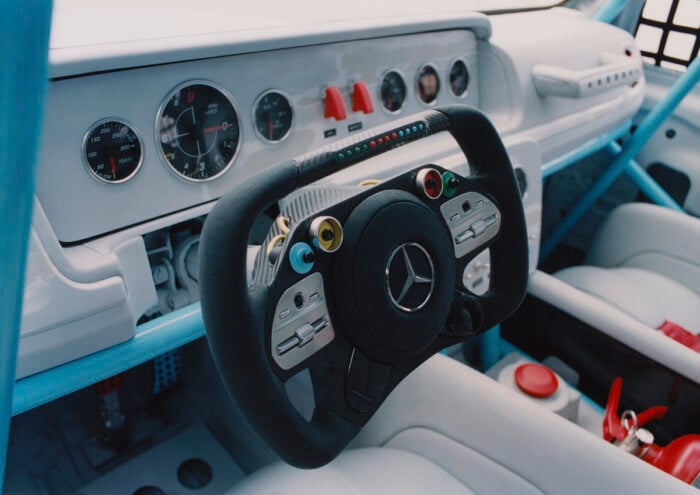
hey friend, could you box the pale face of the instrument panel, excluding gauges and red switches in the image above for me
[37,31,479,242]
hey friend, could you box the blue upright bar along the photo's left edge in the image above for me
[0,0,51,493]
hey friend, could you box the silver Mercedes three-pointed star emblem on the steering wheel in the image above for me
[386,242,435,313]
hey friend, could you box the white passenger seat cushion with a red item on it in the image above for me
[555,266,700,334]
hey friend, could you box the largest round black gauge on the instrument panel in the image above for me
[156,82,240,182]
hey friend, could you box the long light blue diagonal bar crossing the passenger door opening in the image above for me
[540,58,700,259]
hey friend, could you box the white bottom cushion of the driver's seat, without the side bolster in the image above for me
[227,447,474,495]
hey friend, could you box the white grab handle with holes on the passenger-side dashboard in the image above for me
[532,52,642,98]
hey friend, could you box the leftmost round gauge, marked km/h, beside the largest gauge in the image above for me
[83,119,143,184]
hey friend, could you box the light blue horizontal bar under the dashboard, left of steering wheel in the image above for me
[12,303,204,415]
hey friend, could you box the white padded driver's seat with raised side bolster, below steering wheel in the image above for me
[228,355,695,495]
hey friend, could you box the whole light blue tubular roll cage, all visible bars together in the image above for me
[0,0,700,493]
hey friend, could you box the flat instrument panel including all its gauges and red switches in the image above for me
[37,30,479,243]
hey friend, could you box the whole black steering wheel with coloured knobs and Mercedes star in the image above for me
[199,106,528,468]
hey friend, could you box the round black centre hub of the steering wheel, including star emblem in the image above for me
[333,190,455,363]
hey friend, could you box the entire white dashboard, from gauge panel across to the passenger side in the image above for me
[17,1,644,384]
